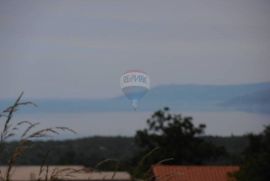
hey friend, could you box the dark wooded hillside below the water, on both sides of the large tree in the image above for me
[0,136,248,167]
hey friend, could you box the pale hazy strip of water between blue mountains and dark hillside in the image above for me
[8,112,270,139]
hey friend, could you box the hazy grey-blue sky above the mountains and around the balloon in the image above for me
[0,0,270,98]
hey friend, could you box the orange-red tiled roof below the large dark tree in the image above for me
[153,165,239,181]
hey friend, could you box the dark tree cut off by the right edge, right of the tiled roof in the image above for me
[235,125,270,181]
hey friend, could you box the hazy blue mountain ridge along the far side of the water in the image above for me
[0,82,270,113]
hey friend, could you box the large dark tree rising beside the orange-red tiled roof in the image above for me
[135,107,225,177]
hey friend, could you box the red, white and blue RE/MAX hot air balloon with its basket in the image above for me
[120,70,150,110]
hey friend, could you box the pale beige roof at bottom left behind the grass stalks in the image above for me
[0,166,131,181]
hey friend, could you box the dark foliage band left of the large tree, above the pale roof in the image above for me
[0,137,138,170]
